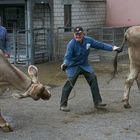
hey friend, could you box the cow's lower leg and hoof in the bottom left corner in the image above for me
[0,112,13,132]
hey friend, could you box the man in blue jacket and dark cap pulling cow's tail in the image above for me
[60,26,120,111]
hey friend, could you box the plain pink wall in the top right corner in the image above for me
[106,0,140,26]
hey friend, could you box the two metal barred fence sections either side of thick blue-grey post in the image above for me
[9,28,51,65]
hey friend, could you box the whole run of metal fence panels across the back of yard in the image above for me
[9,27,128,65]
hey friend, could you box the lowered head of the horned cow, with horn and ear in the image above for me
[14,65,51,100]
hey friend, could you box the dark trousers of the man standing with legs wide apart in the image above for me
[60,67,102,106]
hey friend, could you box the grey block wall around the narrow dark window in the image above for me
[53,0,106,29]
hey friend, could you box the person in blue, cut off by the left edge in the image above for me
[0,17,10,58]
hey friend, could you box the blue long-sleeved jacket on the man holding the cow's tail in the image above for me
[63,36,113,77]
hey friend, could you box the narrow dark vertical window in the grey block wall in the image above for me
[64,4,71,32]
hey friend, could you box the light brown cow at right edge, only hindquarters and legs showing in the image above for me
[114,26,140,108]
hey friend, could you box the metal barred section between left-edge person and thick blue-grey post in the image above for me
[9,29,30,65]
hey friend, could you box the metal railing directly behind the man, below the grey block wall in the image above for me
[55,27,128,63]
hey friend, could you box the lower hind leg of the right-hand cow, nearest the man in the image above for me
[123,69,138,108]
